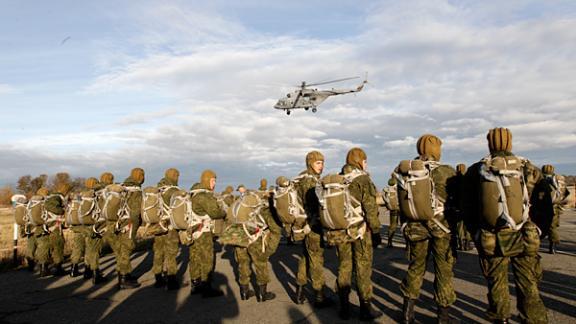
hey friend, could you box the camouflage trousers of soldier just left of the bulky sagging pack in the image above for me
[188,232,215,281]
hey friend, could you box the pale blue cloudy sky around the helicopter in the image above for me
[0,0,576,190]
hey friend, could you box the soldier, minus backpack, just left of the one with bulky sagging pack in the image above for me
[188,170,226,298]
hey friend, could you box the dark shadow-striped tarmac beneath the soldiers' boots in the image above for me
[0,209,576,324]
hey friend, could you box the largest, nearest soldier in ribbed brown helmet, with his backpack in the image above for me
[464,128,548,323]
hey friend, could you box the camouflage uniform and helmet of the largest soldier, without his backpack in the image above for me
[465,128,548,323]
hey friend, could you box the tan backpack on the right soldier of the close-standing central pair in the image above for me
[316,170,367,230]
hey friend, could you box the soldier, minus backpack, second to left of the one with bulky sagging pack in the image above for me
[148,168,180,290]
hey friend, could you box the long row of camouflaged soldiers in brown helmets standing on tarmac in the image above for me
[11,128,567,323]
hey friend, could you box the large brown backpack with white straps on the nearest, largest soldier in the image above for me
[479,156,530,230]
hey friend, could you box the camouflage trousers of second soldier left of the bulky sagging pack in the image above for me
[152,230,180,275]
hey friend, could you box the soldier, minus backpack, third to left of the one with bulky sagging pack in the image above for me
[104,168,144,289]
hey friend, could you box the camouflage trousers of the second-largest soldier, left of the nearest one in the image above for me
[400,222,456,307]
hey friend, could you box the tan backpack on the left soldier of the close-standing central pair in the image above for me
[272,178,306,225]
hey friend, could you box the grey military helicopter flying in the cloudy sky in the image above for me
[274,77,368,115]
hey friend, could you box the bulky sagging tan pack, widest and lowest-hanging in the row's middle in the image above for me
[220,191,268,248]
